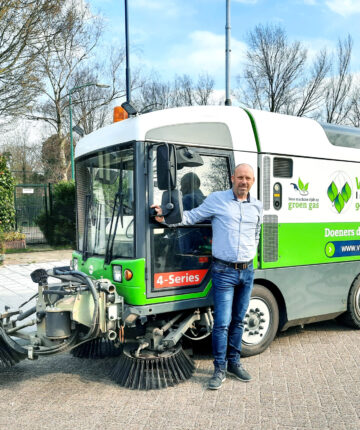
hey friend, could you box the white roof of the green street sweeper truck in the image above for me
[75,106,360,161]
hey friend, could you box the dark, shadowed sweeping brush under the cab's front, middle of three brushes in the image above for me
[71,337,122,359]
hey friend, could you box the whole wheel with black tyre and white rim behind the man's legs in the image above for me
[241,284,279,357]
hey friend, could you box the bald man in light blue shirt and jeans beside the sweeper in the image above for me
[153,164,262,390]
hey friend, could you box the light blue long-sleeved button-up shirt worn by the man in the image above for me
[180,189,262,263]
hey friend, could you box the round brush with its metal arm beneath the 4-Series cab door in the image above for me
[111,308,213,390]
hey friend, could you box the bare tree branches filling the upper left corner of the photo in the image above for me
[0,0,61,116]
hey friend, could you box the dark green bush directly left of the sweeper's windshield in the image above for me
[36,181,76,248]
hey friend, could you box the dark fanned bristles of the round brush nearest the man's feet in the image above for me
[110,345,195,390]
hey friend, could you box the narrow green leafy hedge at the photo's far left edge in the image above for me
[0,155,15,231]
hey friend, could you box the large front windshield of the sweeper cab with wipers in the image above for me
[76,147,135,258]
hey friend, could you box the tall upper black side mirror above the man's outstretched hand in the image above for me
[156,143,176,190]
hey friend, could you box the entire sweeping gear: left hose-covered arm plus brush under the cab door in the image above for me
[0,267,212,390]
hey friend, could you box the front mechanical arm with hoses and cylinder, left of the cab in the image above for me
[0,267,123,368]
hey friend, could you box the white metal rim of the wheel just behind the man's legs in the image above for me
[242,297,272,345]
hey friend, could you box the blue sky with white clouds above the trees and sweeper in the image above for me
[88,0,360,95]
